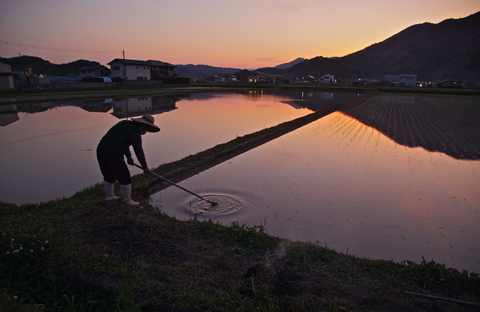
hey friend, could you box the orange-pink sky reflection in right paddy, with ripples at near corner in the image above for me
[152,112,480,272]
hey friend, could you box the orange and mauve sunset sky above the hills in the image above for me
[0,0,480,69]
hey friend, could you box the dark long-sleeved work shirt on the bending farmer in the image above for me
[98,120,147,168]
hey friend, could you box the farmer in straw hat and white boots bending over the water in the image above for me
[97,115,160,206]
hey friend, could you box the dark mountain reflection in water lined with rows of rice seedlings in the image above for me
[341,95,480,160]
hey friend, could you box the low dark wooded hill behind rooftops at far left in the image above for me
[0,56,100,76]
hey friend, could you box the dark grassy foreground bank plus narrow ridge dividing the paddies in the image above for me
[0,85,480,311]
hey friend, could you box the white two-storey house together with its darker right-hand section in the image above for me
[108,59,175,80]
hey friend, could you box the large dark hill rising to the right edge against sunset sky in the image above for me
[260,12,480,82]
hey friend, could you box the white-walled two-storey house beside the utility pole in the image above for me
[108,59,151,80]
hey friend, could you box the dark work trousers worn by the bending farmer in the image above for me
[97,147,132,185]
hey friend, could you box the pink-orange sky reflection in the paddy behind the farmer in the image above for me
[0,93,311,204]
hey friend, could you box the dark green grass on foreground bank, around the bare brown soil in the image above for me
[0,196,480,311]
